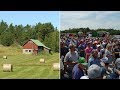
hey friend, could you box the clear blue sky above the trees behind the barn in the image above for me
[0,11,60,29]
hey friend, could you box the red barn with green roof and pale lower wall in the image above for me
[23,39,50,54]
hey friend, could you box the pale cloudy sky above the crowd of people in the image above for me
[60,11,120,30]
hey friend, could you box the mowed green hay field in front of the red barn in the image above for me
[0,46,59,79]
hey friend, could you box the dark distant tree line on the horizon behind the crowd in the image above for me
[61,27,120,35]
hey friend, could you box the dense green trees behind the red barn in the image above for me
[0,20,59,52]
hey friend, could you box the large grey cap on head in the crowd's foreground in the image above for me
[88,64,102,79]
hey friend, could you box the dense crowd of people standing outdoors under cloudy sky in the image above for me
[60,33,120,79]
